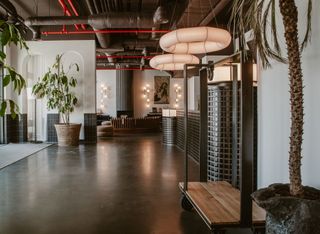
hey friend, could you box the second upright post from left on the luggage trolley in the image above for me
[200,67,211,182]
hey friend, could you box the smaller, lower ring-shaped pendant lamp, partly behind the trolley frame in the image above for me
[149,54,200,71]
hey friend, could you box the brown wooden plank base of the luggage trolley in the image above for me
[179,181,266,230]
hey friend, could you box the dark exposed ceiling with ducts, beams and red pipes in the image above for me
[2,0,233,68]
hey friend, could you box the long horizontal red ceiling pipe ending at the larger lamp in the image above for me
[41,29,170,35]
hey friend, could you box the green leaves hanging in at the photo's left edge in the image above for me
[0,19,28,118]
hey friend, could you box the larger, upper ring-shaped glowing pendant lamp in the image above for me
[159,27,231,54]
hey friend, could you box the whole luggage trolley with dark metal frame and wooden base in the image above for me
[179,53,266,234]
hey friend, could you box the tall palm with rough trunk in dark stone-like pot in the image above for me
[231,0,320,234]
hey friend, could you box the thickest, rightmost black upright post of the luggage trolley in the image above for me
[240,53,254,227]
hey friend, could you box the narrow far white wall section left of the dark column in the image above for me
[97,70,117,117]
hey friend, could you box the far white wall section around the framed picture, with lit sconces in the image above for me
[133,70,184,117]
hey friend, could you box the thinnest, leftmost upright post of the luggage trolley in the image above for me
[183,64,189,191]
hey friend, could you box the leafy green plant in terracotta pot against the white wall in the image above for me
[32,55,81,146]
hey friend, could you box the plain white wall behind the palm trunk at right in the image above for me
[258,1,320,188]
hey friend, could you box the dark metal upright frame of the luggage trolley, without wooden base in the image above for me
[183,52,254,227]
